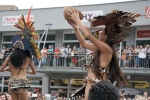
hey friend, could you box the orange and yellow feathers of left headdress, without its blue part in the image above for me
[14,7,41,59]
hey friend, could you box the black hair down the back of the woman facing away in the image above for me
[10,48,31,68]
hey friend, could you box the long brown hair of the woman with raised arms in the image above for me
[91,26,128,87]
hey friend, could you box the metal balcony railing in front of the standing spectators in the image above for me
[0,54,150,68]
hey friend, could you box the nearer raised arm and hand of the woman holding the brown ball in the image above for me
[68,8,112,54]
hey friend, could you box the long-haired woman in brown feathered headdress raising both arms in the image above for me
[68,8,140,100]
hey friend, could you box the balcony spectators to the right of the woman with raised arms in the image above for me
[117,44,150,68]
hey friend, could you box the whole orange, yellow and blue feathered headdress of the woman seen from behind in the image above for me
[12,7,41,59]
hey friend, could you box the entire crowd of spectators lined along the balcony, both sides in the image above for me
[0,44,150,68]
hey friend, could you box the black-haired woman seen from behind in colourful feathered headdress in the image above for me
[0,6,41,100]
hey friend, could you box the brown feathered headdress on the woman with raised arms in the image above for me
[89,10,141,44]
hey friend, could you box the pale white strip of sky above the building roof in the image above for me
[0,0,135,9]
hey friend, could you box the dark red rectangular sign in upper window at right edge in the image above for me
[137,30,150,38]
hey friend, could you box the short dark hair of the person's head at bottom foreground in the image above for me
[88,81,119,100]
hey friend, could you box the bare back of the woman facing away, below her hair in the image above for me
[10,58,30,79]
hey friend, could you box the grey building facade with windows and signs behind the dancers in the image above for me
[0,0,150,96]
